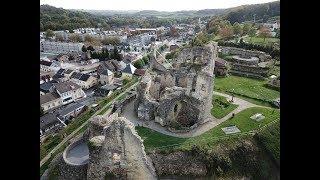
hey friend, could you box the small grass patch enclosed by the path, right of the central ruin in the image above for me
[211,95,238,119]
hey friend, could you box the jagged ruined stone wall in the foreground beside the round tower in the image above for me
[87,114,156,180]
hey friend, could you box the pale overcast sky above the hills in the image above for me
[40,0,275,11]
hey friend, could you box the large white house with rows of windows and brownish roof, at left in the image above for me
[55,81,86,104]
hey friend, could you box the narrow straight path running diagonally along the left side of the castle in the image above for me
[40,81,139,167]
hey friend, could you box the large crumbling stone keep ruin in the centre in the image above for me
[135,43,217,129]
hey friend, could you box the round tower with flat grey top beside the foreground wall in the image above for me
[63,139,89,166]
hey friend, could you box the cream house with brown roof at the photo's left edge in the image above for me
[40,92,63,112]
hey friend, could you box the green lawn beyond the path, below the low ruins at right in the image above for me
[214,76,280,106]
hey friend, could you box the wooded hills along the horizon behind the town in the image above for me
[40,1,280,31]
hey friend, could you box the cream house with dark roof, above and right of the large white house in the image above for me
[70,72,98,89]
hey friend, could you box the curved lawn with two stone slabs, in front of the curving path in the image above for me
[136,107,280,152]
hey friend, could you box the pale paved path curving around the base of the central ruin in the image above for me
[121,91,265,138]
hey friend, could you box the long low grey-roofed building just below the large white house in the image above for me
[58,103,85,122]
